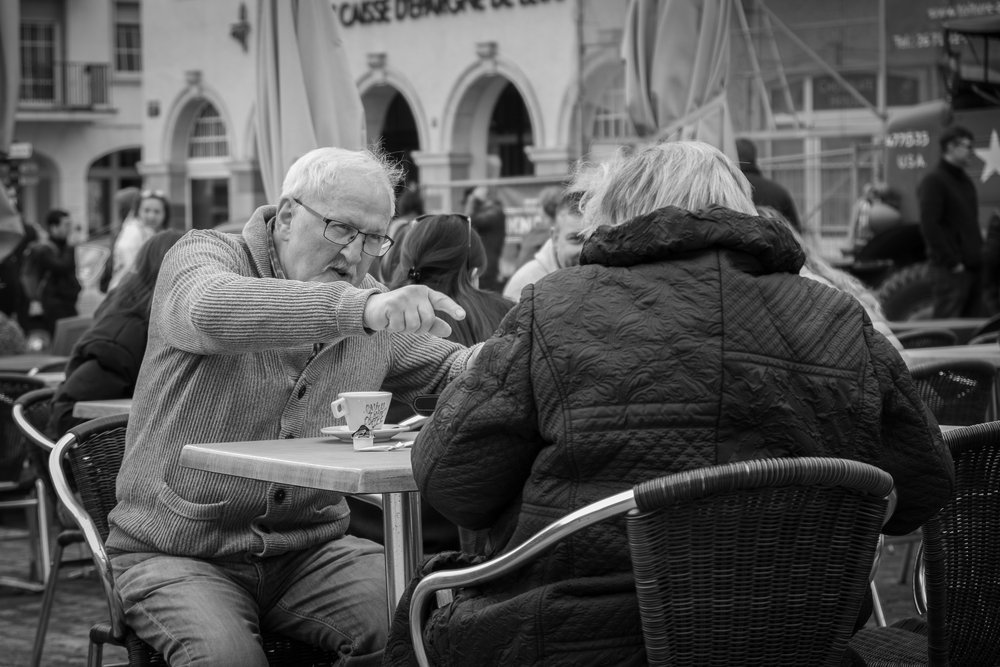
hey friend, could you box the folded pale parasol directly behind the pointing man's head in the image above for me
[256,0,366,203]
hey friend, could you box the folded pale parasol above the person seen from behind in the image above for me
[622,0,736,159]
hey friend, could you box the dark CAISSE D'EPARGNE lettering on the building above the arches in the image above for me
[333,0,564,28]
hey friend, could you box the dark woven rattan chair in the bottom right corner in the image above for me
[852,421,1000,665]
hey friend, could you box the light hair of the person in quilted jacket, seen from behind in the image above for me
[571,141,756,236]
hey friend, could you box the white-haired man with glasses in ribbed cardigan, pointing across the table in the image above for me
[108,148,472,667]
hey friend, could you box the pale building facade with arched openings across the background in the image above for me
[5,0,997,258]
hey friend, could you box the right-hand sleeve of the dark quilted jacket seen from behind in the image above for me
[865,327,955,535]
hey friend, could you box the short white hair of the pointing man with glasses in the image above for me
[281,146,403,217]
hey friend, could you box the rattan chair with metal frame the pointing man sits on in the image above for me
[49,415,348,667]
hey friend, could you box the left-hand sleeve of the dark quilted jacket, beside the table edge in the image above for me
[413,300,540,529]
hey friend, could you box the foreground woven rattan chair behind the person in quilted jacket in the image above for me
[409,458,892,666]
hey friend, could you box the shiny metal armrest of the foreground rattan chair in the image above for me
[410,489,636,667]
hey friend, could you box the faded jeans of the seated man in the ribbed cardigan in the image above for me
[112,536,388,667]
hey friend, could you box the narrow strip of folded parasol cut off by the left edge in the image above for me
[0,2,24,260]
